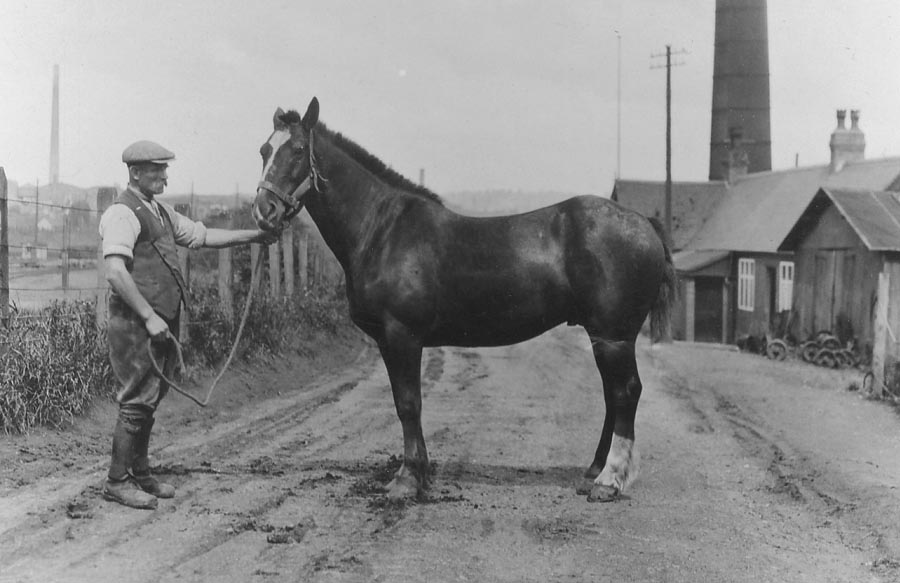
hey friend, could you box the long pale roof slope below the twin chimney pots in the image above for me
[687,158,900,253]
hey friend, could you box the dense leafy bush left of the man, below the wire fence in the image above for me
[0,301,116,433]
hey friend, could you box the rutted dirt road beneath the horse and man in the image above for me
[0,328,900,583]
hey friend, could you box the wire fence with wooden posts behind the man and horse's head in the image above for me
[0,173,343,329]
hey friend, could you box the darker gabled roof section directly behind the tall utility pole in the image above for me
[612,180,726,249]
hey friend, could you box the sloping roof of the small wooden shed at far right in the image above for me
[822,189,900,251]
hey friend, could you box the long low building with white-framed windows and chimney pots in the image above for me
[612,111,900,343]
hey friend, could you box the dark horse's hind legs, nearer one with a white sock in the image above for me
[578,335,642,502]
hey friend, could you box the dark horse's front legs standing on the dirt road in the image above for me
[379,330,431,498]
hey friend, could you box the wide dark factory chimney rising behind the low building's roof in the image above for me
[709,0,772,180]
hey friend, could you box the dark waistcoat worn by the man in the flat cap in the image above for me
[113,189,188,320]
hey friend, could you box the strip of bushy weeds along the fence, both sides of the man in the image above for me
[0,230,349,433]
